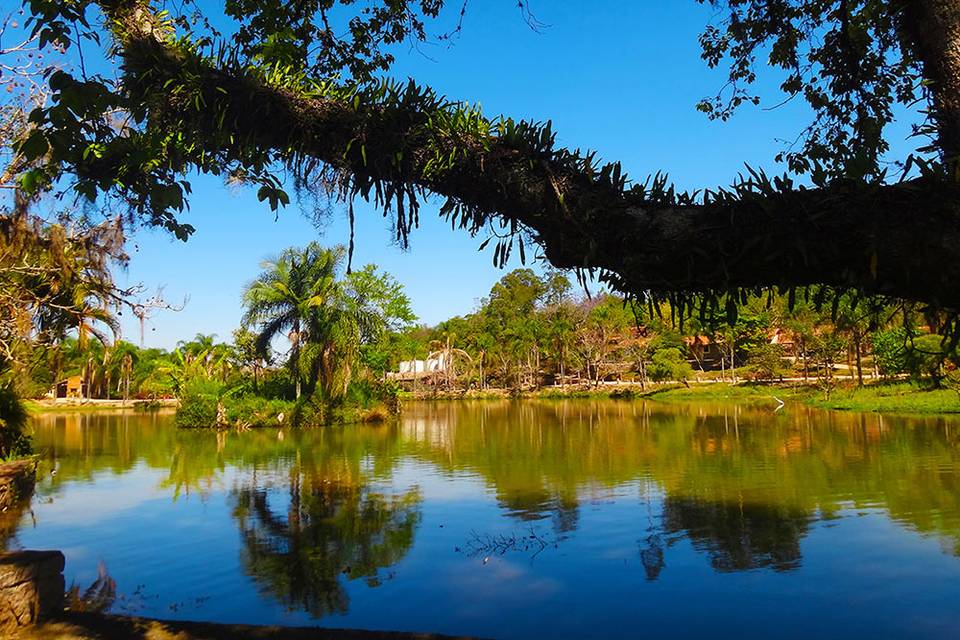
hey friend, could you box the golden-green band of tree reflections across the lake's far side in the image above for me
[22,400,960,580]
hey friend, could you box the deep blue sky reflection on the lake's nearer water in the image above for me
[11,410,960,638]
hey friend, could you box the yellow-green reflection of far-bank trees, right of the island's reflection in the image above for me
[402,401,960,573]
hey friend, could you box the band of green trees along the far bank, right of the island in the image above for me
[376,269,957,390]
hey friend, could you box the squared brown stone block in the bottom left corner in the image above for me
[0,551,64,637]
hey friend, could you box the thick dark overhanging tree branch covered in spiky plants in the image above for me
[88,3,960,309]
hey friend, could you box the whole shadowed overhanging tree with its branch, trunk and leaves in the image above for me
[13,0,960,336]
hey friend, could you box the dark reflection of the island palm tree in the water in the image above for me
[232,471,420,617]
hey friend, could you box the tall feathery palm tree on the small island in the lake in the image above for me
[243,242,381,399]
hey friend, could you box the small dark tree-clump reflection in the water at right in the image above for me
[663,496,810,571]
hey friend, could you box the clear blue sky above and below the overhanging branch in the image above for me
[109,0,903,348]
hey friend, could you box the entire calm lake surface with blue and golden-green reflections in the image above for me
[0,401,960,638]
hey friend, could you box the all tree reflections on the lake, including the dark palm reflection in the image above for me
[11,401,960,632]
